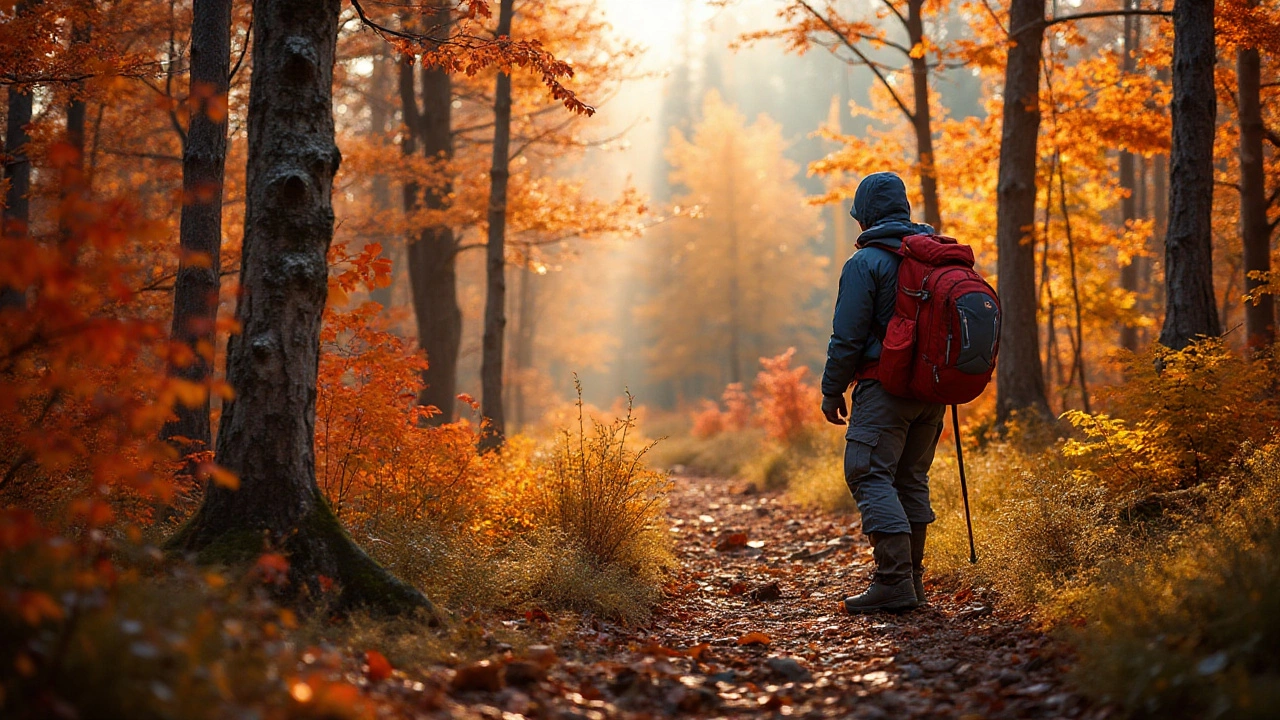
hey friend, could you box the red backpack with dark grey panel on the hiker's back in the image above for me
[876,234,1000,405]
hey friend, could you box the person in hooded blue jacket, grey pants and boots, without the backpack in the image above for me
[822,172,946,614]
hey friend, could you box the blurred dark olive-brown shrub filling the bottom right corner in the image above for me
[1074,442,1280,717]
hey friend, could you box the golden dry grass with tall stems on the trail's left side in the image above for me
[357,381,673,623]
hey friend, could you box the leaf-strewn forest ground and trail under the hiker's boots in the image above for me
[375,477,1108,720]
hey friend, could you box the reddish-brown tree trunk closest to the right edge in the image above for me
[1235,11,1276,348]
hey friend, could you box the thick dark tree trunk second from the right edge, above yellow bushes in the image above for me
[1160,0,1222,350]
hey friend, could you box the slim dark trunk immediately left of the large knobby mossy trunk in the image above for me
[160,0,232,452]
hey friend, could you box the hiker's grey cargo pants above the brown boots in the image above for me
[845,380,946,534]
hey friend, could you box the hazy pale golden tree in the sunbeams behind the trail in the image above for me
[643,92,833,393]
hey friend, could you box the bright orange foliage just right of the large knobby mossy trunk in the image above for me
[316,245,534,537]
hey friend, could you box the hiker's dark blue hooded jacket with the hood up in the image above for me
[822,173,933,396]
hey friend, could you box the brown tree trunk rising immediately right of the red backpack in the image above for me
[996,0,1050,424]
